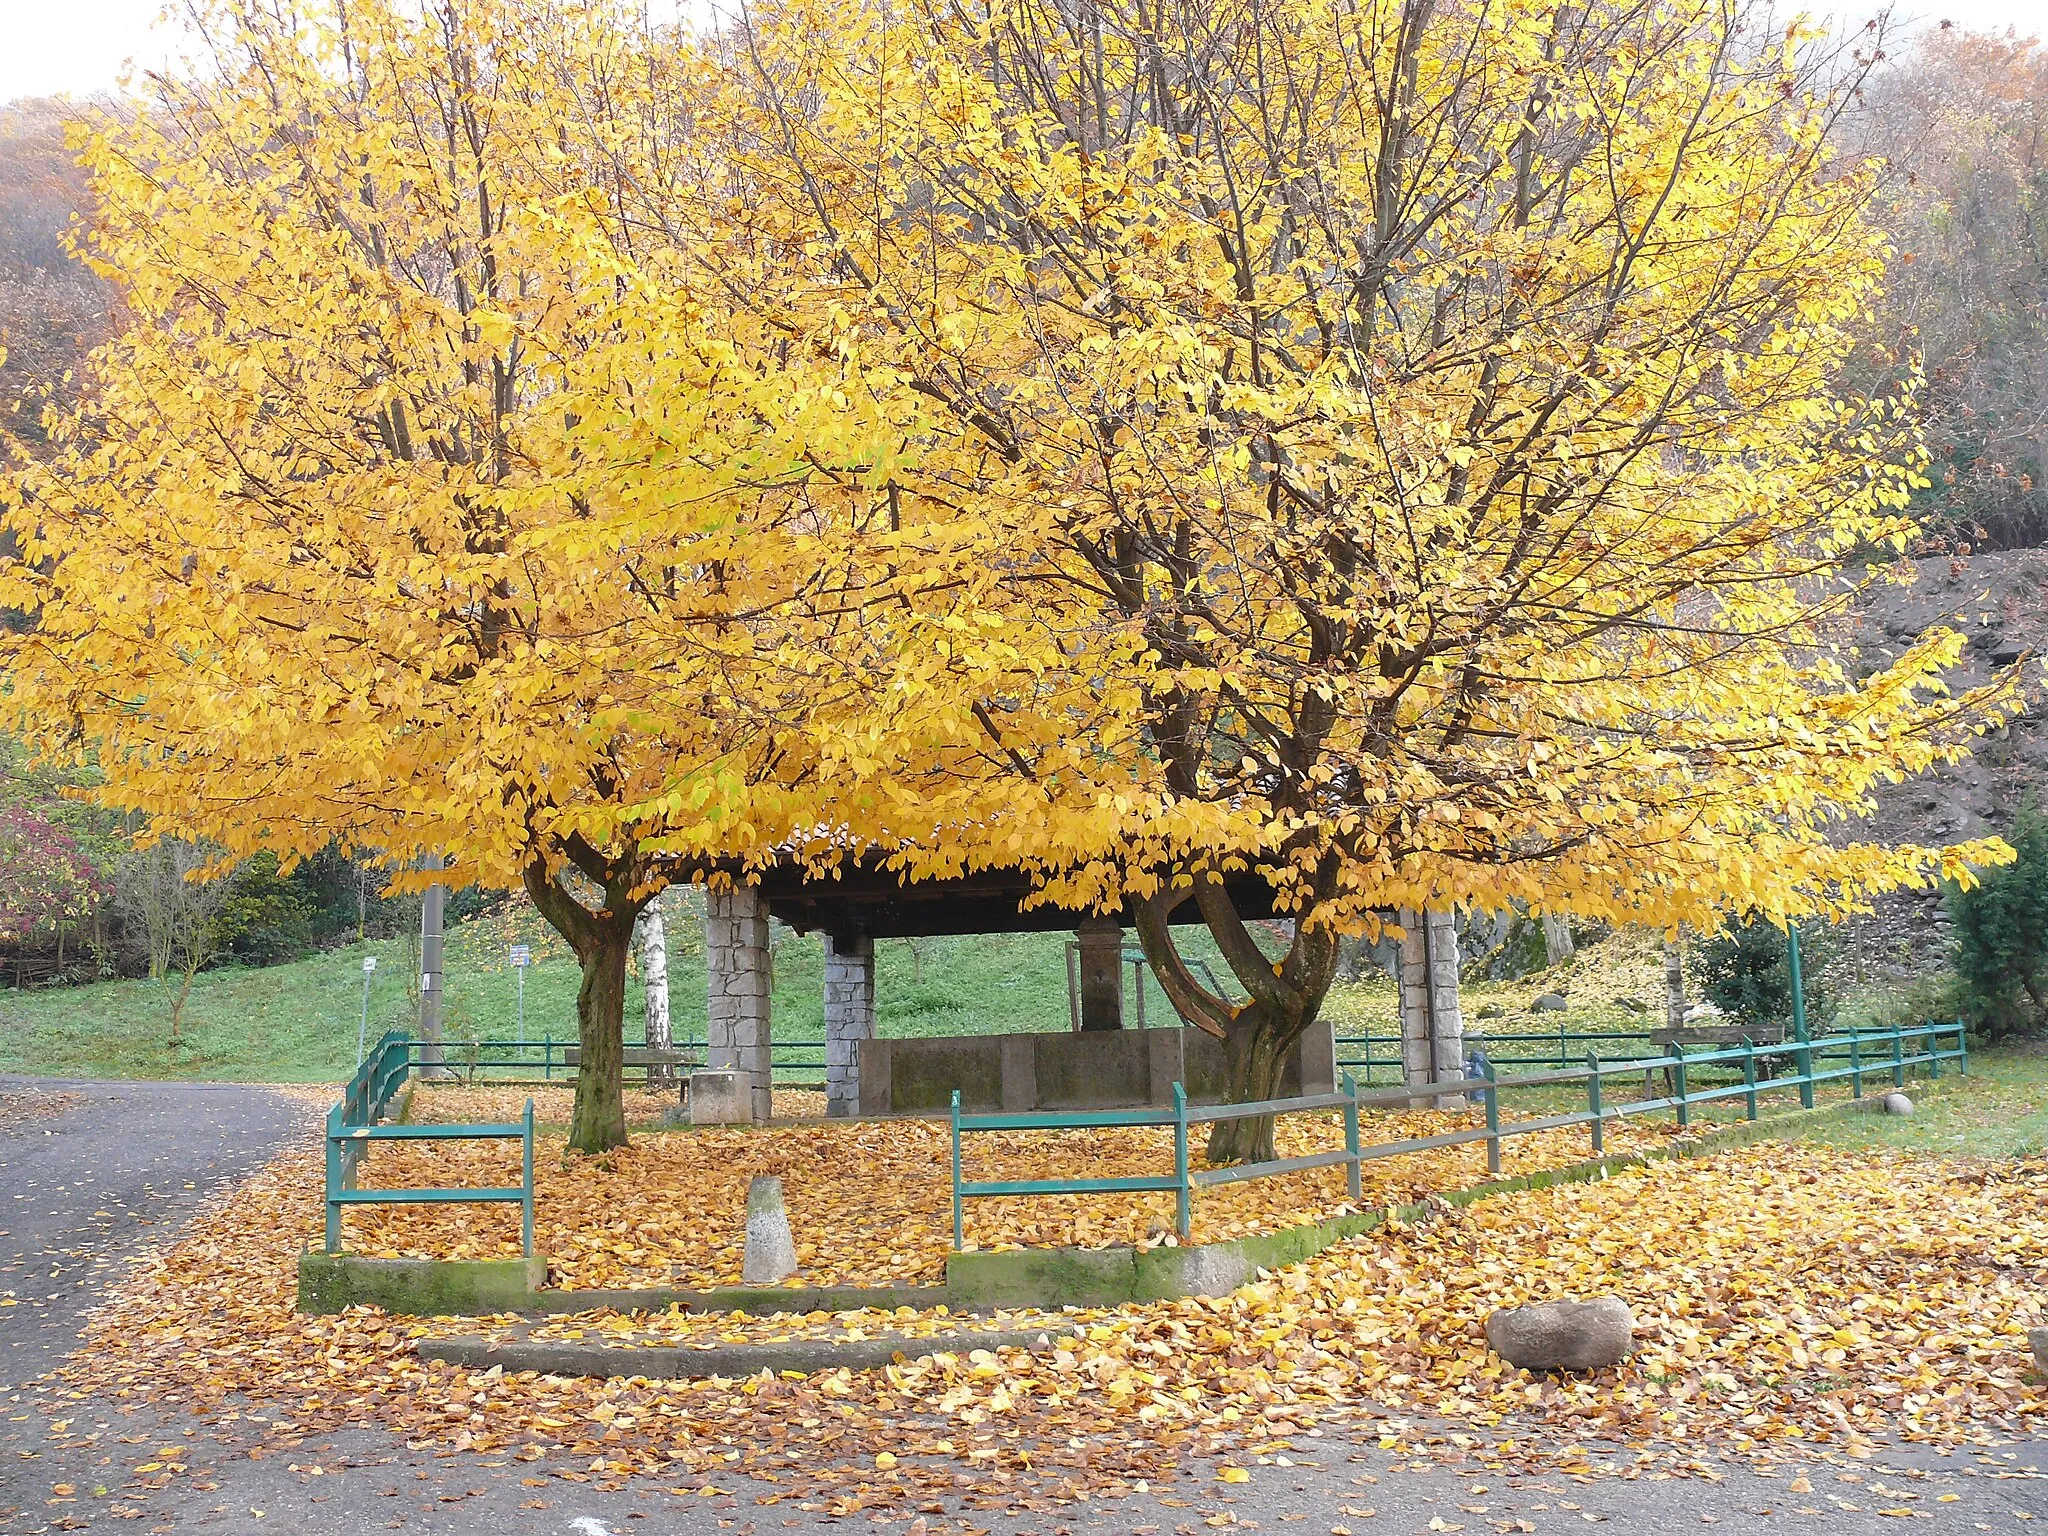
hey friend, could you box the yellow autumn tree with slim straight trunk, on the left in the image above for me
[4,0,901,1151]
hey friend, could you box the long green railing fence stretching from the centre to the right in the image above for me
[952,1022,1970,1249]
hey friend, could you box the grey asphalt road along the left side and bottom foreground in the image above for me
[0,1079,2048,1536]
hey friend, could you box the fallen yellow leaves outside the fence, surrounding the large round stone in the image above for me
[51,1097,2048,1513]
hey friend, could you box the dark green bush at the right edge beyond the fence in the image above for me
[1948,805,2048,1040]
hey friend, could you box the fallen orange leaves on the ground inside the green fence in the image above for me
[344,1087,1673,1288]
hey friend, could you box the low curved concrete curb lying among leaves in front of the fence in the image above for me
[420,1327,1079,1380]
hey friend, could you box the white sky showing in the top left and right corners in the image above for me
[0,0,2048,102]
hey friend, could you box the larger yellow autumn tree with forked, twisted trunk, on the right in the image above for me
[688,0,2009,1155]
